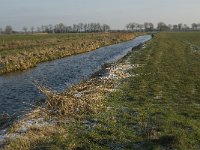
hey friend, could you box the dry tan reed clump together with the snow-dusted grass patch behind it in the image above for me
[38,64,134,118]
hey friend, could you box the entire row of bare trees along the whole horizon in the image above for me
[0,22,200,34]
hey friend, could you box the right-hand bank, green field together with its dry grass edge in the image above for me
[3,33,200,150]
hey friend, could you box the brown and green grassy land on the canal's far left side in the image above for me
[0,33,140,74]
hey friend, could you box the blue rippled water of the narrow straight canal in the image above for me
[0,35,151,115]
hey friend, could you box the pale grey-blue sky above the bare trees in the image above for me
[0,0,200,30]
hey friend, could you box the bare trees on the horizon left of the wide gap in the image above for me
[0,23,111,34]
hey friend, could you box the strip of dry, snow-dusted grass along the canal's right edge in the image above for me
[1,35,152,148]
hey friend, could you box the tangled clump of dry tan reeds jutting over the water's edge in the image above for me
[39,79,112,119]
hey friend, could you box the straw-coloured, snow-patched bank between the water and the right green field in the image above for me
[2,41,148,149]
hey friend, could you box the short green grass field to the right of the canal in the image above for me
[97,33,200,149]
